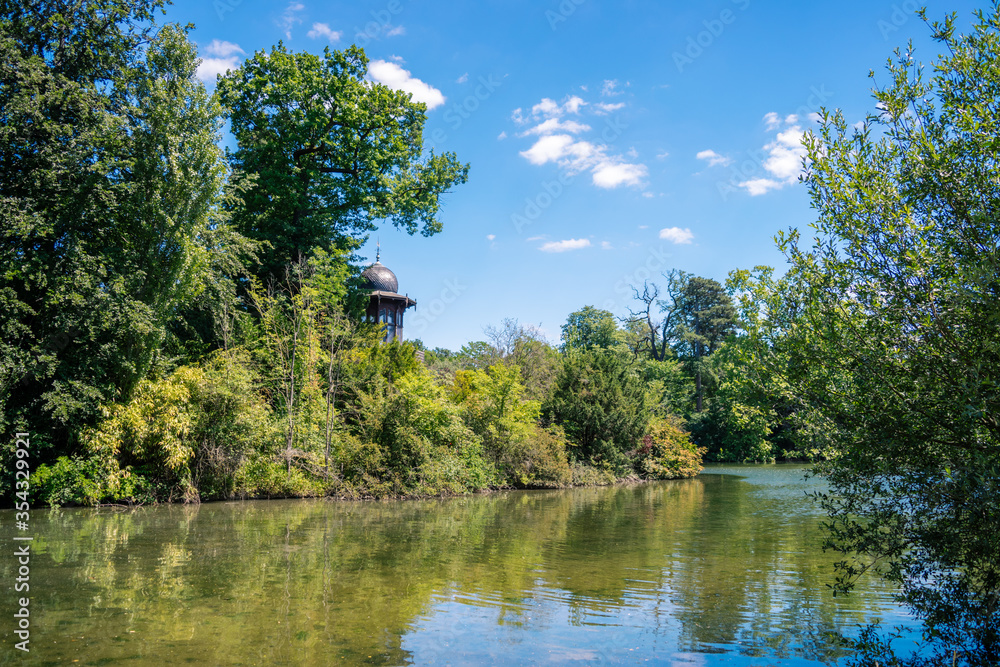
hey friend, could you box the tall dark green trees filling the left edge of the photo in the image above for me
[0,5,226,462]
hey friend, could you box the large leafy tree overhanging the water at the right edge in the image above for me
[751,5,1000,665]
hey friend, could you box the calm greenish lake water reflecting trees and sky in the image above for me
[0,466,905,665]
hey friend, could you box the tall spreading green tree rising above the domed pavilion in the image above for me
[218,43,469,280]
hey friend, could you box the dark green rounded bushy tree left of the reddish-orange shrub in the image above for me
[545,348,649,474]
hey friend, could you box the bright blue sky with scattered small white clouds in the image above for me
[166,0,982,349]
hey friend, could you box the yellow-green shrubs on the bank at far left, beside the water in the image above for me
[36,356,278,504]
